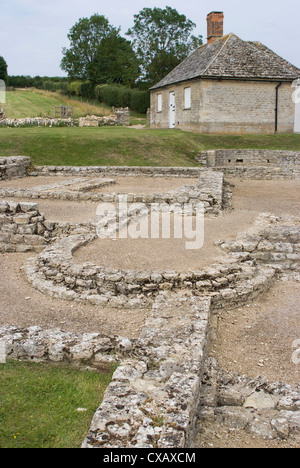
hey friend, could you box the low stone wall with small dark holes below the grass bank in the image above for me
[196,149,300,180]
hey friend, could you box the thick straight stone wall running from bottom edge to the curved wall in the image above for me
[82,295,210,448]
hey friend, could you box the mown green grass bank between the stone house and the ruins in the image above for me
[0,127,300,166]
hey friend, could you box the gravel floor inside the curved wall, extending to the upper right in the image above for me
[74,180,300,272]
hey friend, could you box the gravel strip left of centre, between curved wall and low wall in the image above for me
[0,253,150,338]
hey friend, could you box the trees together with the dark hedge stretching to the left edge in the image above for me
[0,6,202,112]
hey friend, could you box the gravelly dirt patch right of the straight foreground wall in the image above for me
[208,281,300,386]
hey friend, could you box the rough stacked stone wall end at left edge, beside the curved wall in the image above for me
[0,201,51,252]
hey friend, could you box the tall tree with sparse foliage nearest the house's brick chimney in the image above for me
[126,6,202,84]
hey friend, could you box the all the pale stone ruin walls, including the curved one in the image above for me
[0,156,300,449]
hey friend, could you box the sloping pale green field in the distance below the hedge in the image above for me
[4,88,111,119]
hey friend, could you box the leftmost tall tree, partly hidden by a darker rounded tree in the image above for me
[60,14,119,80]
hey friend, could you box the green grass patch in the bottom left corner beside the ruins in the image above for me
[0,361,111,448]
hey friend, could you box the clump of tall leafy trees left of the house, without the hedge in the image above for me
[61,6,202,89]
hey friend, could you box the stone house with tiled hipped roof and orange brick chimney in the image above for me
[150,12,300,134]
